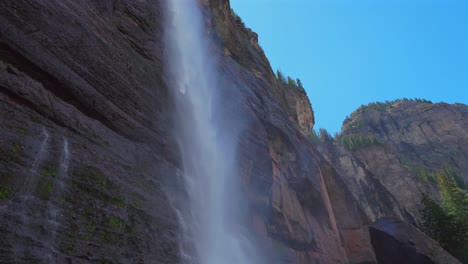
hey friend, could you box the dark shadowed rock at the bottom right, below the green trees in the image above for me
[369,218,461,264]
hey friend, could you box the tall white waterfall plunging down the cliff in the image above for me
[166,0,263,264]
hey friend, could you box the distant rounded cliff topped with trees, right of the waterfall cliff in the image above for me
[322,100,468,225]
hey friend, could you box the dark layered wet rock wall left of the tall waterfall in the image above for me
[0,0,178,263]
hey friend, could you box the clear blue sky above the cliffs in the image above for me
[231,0,468,133]
